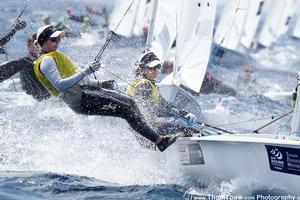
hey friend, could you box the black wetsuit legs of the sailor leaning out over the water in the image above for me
[61,85,159,142]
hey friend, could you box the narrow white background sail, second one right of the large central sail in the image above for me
[240,0,264,48]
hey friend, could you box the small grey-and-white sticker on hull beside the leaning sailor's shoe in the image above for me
[178,144,204,165]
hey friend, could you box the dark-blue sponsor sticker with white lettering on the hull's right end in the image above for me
[265,145,300,176]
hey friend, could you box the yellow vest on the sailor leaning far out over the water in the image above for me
[34,51,78,96]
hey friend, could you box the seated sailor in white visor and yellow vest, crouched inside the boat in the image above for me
[127,52,197,134]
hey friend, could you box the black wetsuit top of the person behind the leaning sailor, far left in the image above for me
[0,56,51,101]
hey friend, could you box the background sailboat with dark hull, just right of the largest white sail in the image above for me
[212,0,264,67]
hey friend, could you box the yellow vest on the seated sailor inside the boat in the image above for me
[126,78,159,103]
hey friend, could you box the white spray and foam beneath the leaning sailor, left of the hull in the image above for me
[0,90,166,185]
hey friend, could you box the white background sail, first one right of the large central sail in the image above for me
[214,0,250,50]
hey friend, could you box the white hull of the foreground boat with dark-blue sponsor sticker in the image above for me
[167,134,300,194]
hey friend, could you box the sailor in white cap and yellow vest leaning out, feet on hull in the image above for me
[34,25,176,151]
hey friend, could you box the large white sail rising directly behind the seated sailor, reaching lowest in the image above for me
[174,0,216,93]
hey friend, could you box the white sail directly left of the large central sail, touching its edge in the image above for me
[147,0,177,61]
